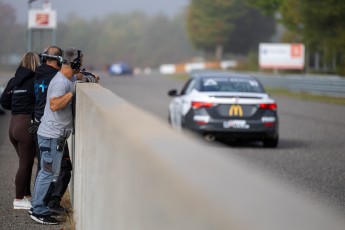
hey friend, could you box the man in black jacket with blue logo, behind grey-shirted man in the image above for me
[33,46,72,214]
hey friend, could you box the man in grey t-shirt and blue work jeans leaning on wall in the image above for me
[30,48,96,225]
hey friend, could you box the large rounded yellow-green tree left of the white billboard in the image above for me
[186,0,276,60]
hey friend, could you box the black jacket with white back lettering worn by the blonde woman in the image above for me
[11,66,35,115]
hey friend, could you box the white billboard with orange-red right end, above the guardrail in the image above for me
[259,43,305,69]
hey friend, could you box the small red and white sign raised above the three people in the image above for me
[28,9,56,29]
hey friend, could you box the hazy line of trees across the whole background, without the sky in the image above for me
[0,0,345,73]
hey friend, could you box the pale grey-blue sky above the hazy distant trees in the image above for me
[0,0,189,22]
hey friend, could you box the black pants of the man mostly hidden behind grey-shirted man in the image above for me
[34,135,72,207]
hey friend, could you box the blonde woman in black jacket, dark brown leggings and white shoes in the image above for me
[9,52,40,209]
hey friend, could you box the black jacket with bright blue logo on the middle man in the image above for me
[34,64,59,121]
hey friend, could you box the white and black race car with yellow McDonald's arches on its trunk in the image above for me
[168,71,279,148]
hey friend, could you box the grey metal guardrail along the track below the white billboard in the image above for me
[252,73,345,98]
